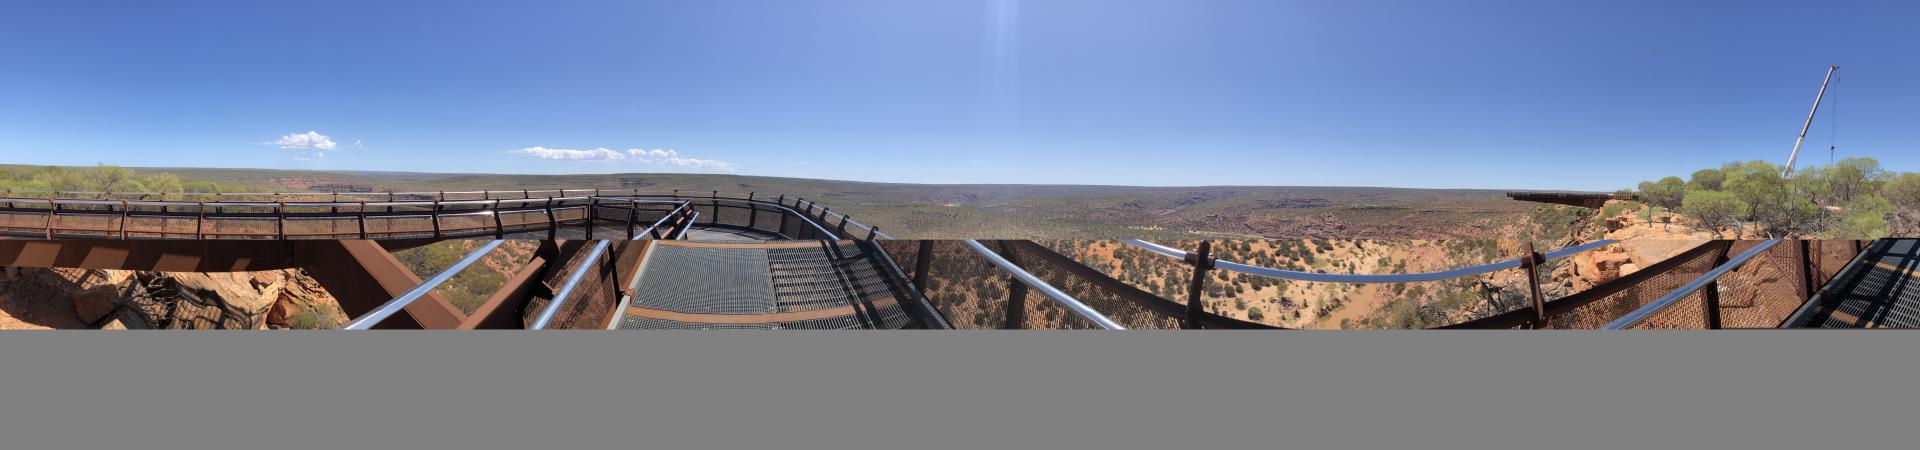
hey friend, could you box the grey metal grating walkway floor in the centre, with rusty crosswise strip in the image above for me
[611,240,927,329]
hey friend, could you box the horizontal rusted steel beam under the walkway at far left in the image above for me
[0,238,296,271]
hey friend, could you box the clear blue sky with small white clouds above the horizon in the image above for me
[0,0,1920,190]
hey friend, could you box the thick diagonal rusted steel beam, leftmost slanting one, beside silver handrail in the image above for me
[296,240,467,329]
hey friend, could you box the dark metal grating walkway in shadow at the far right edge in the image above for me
[1782,238,1920,329]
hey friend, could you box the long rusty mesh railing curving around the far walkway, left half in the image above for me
[0,188,893,240]
